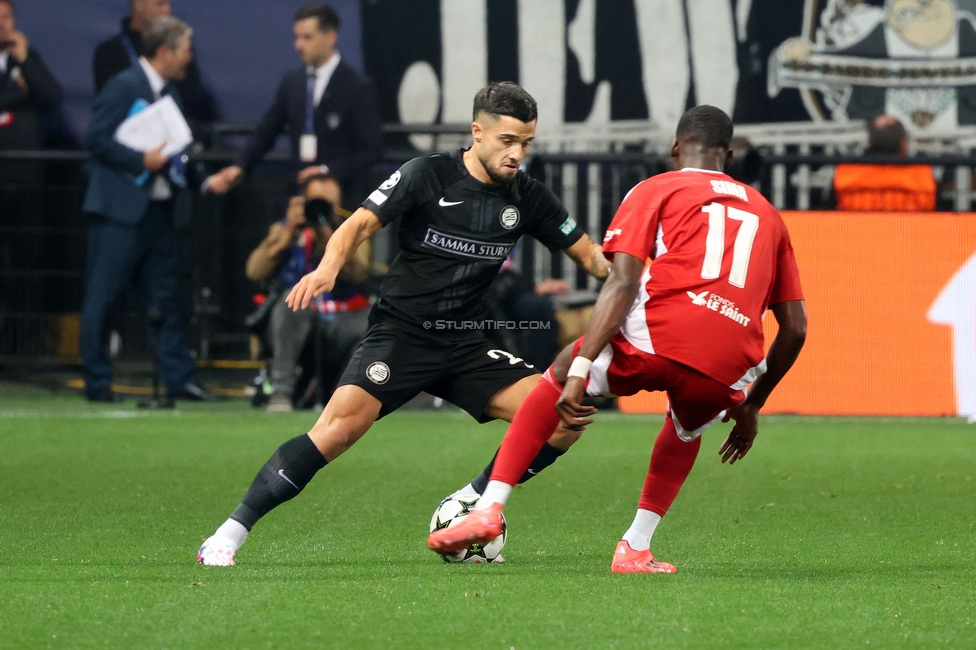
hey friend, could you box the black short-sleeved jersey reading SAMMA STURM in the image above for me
[362,149,583,335]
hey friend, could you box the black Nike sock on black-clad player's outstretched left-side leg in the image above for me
[230,434,326,531]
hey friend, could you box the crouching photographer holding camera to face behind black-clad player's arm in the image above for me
[246,176,370,413]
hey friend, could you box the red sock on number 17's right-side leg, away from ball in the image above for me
[639,413,701,517]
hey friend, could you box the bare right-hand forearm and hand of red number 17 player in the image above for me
[718,300,807,464]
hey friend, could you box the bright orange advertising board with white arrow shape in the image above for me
[620,212,976,415]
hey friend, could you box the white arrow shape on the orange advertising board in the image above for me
[926,253,976,417]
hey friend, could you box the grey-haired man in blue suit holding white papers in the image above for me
[81,16,213,402]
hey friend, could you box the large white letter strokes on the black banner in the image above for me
[418,0,742,140]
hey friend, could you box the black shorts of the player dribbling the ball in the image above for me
[339,323,544,422]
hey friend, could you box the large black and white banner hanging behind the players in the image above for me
[362,0,976,135]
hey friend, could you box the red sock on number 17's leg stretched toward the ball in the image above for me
[490,378,562,485]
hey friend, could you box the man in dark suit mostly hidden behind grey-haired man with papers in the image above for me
[92,0,219,124]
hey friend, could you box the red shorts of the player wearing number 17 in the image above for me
[573,334,746,442]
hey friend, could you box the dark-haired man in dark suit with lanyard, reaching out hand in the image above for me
[207,3,382,208]
